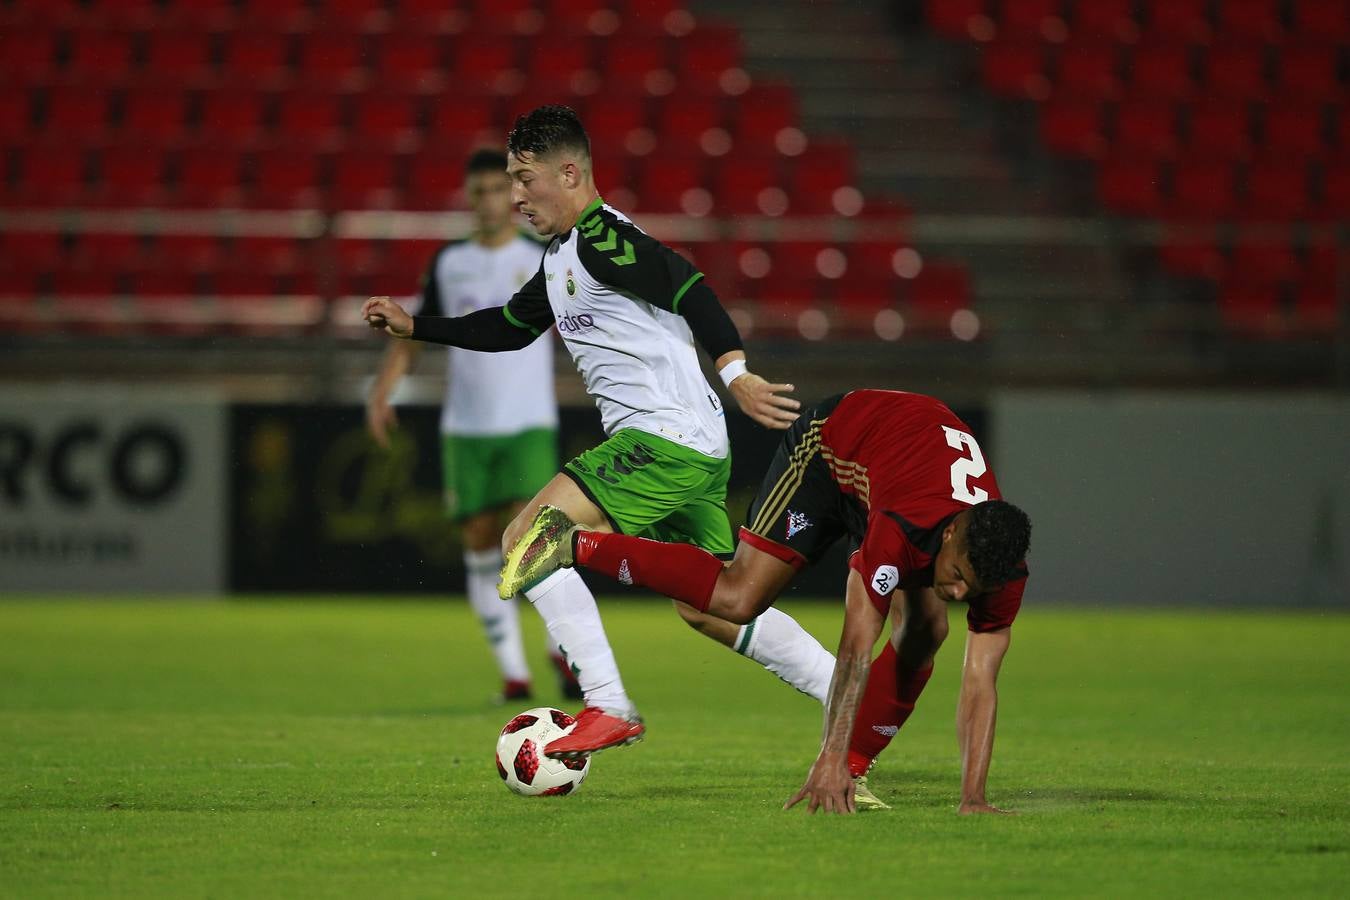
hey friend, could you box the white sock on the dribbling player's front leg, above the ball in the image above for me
[525,569,637,716]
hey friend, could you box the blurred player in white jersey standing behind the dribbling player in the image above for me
[366,148,581,700]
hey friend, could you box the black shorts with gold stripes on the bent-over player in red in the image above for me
[741,394,867,567]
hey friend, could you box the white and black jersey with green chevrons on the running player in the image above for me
[505,198,729,459]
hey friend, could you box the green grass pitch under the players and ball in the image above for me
[0,599,1350,897]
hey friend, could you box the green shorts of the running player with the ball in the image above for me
[563,428,734,555]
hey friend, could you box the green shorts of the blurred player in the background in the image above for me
[440,428,558,519]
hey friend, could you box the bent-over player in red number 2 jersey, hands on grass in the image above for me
[510,390,1031,814]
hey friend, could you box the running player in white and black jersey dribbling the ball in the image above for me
[362,107,834,758]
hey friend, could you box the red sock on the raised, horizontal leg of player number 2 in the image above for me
[574,532,722,613]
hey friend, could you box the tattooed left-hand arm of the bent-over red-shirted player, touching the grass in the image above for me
[783,569,886,812]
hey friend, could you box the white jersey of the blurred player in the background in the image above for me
[409,235,558,437]
